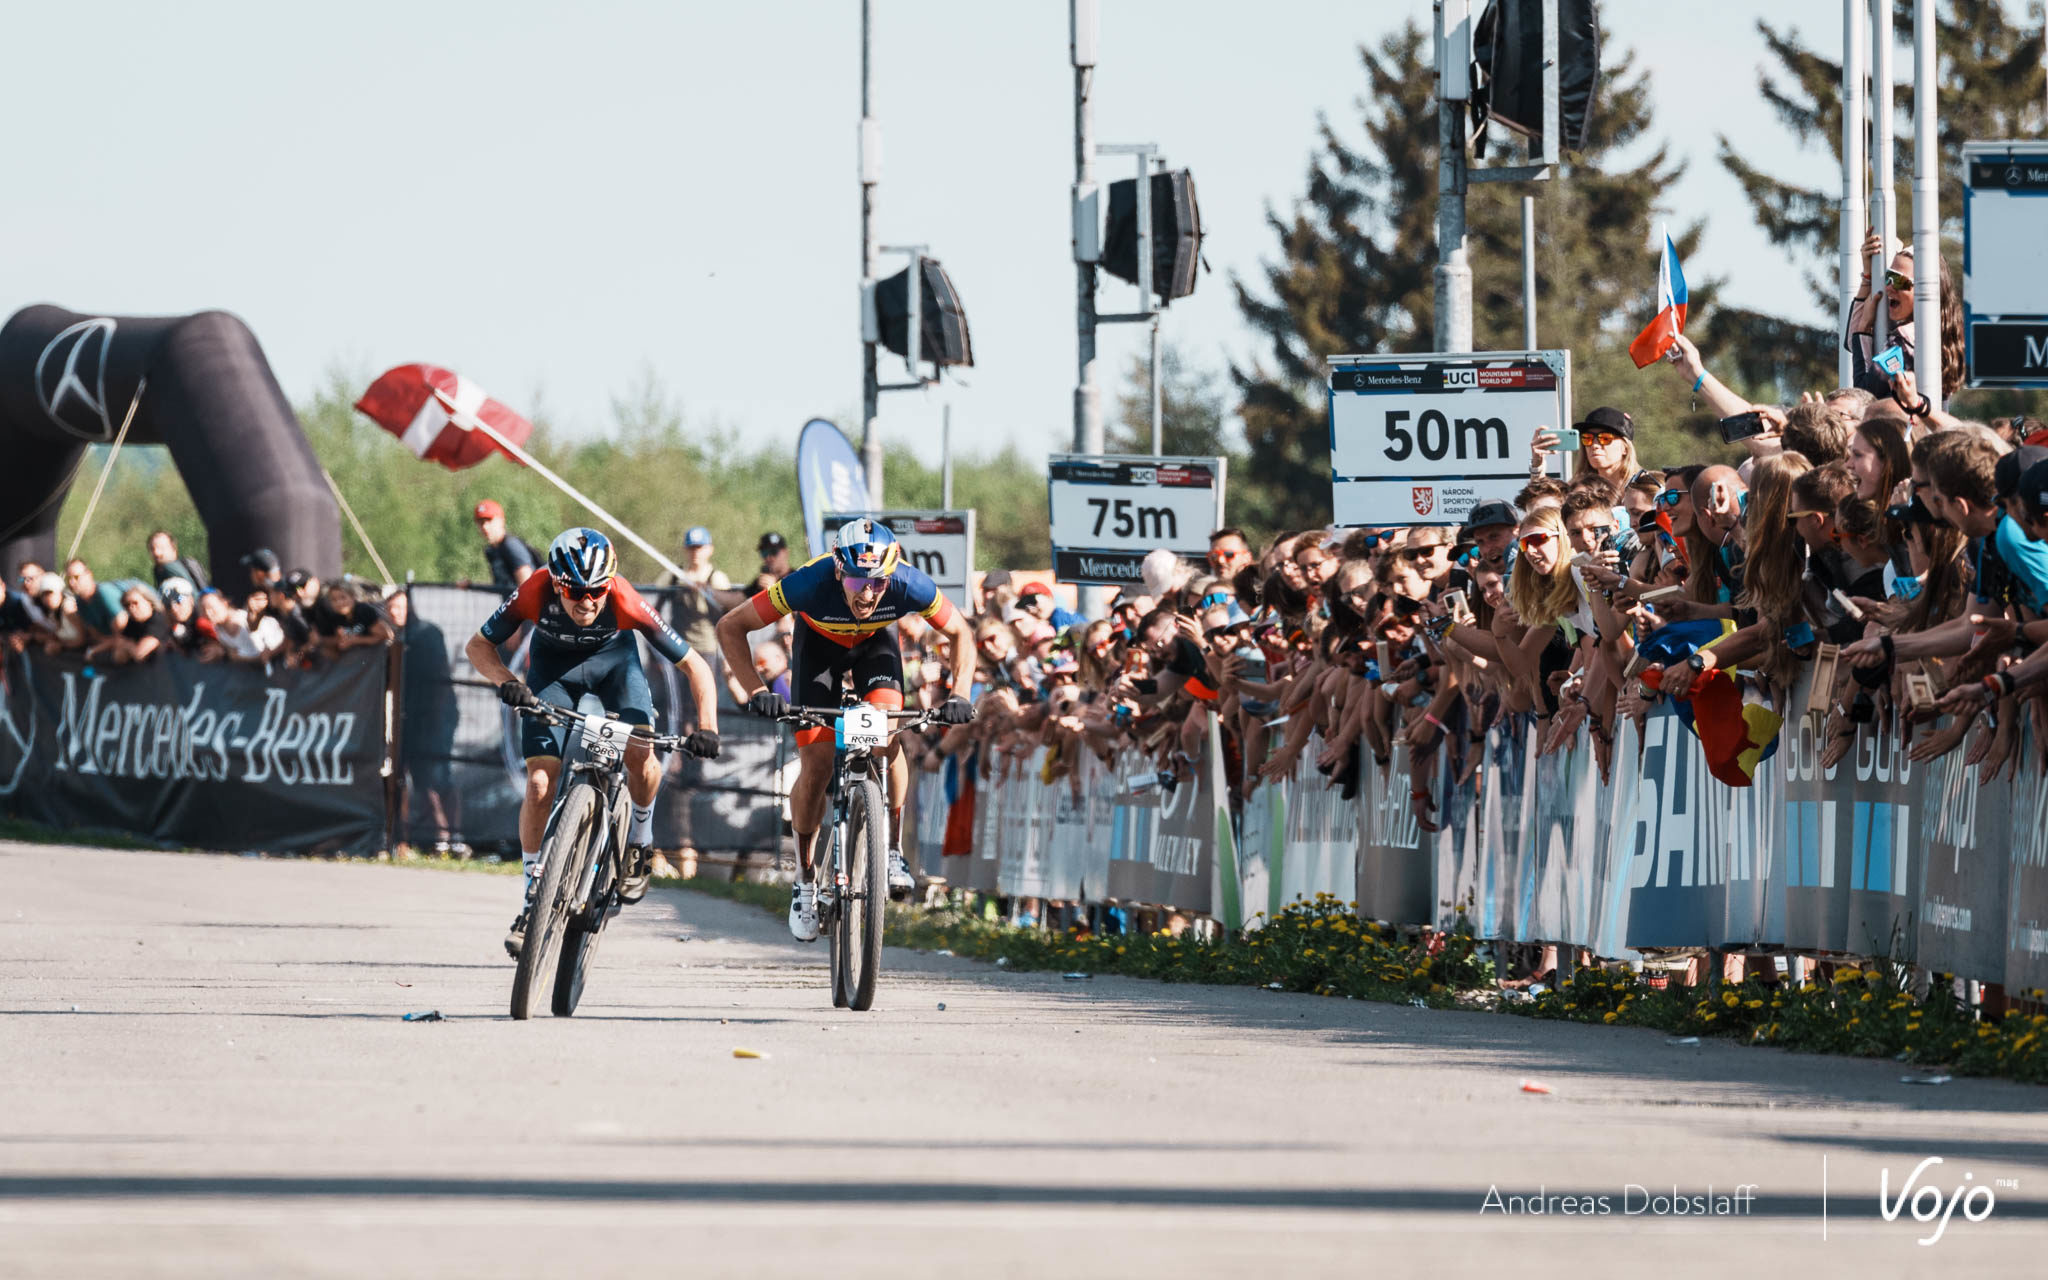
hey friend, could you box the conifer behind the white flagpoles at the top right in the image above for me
[1718,0,2048,414]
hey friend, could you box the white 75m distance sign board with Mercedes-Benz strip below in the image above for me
[1047,453,1225,586]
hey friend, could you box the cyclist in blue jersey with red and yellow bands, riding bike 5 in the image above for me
[719,518,975,942]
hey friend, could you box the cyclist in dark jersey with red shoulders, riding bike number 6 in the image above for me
[465,528,719,956]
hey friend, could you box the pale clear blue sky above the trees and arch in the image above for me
[0,0,1875,468]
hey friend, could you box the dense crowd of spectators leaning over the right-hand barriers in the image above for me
[856,319,2048,847]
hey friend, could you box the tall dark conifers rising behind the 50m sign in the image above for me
[1231,23,1716,526]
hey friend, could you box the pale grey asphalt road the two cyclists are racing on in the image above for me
[0,844,2048,1280]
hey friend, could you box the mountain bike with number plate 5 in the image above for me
[780,702,938,1010]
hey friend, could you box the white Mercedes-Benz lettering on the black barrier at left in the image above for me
[55,672,356,786]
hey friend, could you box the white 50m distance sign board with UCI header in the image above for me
[1329,350,1573,526]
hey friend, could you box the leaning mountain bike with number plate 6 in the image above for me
[512,702,682,1022]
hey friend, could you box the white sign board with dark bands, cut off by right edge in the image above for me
[1962,141,2048,387]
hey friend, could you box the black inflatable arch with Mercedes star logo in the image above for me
[0,305,342,594]
